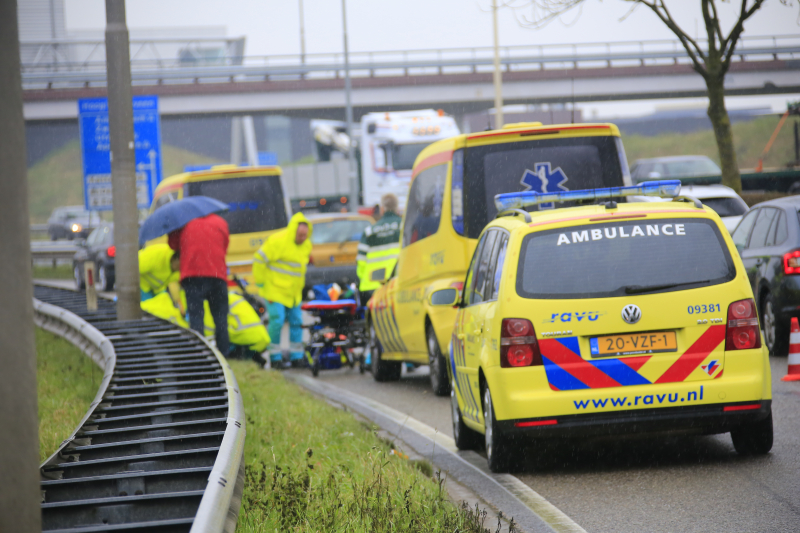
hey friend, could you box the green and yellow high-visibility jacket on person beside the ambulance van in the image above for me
[356,213,402,291]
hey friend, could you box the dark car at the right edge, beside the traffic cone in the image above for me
[732,196,800,355]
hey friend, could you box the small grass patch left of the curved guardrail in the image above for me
[36,328,103,461]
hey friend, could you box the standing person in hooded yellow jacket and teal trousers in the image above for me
[253,213,313,367]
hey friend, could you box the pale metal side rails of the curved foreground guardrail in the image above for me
[33,298,246,533]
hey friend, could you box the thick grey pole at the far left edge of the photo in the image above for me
[0,0,42,533]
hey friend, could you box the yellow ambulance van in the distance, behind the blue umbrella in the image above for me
[150,165,291,287]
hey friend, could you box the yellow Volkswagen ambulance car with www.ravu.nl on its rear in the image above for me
[430,181,773,472]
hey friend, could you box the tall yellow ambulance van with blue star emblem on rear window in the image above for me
[368,122,630,395]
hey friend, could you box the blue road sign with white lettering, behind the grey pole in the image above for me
[78,96,163,211]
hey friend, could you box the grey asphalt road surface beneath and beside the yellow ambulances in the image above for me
[290,357,800,533]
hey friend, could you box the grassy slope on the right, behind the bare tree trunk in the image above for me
[622,116,797,169]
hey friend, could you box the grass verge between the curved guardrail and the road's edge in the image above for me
[231,361,514,533]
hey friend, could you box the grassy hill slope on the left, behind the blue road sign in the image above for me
[28,139,220,223]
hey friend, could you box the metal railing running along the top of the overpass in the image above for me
[22,35,800,89]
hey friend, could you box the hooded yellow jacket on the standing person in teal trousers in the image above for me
[253,213,313,307]
